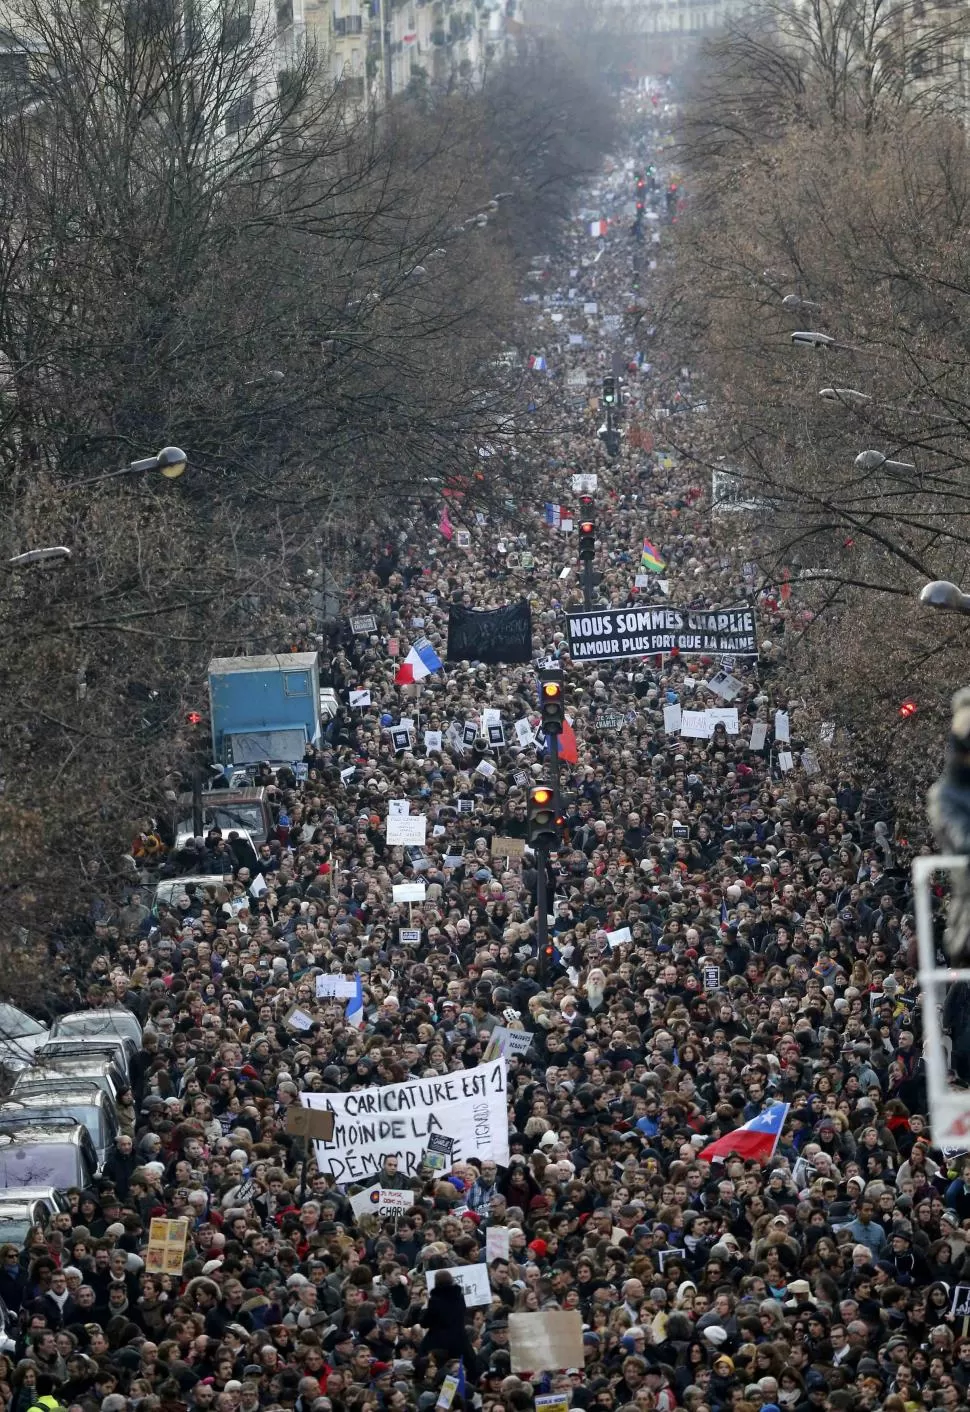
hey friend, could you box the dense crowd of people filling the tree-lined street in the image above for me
[0,86,948,1412]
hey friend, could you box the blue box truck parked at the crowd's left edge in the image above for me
[209,652,322,768]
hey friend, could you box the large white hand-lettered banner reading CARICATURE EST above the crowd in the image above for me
[301,1059,508,1182]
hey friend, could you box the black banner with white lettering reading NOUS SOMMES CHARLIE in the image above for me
[569,604,758,662]
